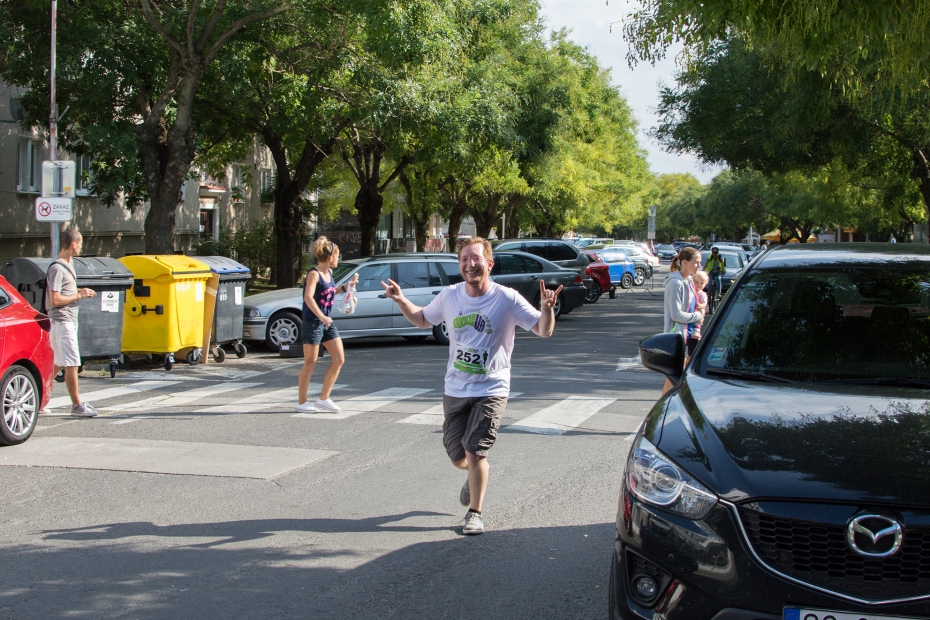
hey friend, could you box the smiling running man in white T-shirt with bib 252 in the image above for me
[381,237,562,535]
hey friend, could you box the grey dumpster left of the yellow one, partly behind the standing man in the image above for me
[0,256,132,377]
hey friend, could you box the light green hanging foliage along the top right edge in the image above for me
[624,0,930,90]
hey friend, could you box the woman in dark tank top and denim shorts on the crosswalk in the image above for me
[296,237,358,413]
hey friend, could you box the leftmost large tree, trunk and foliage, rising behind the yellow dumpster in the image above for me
[0,0,289,253]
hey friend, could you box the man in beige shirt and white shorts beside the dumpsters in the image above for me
[45,228,97,418]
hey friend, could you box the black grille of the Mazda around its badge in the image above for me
[740,509,930,601]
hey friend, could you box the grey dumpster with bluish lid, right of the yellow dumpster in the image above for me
[196,256,252,362]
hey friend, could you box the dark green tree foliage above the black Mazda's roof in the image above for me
[655,39,930,237]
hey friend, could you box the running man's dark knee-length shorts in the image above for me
[442,394,507,461]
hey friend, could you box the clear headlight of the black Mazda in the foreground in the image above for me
[626,437,717,519]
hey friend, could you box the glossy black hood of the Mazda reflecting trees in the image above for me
[646,373,930,507]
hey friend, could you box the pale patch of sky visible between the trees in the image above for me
[540,0,720,183]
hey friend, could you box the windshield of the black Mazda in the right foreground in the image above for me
[697,268,930,385]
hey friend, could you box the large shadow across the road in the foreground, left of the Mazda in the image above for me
[0,512,615,620]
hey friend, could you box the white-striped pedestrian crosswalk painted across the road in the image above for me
[40,375,640,435]
